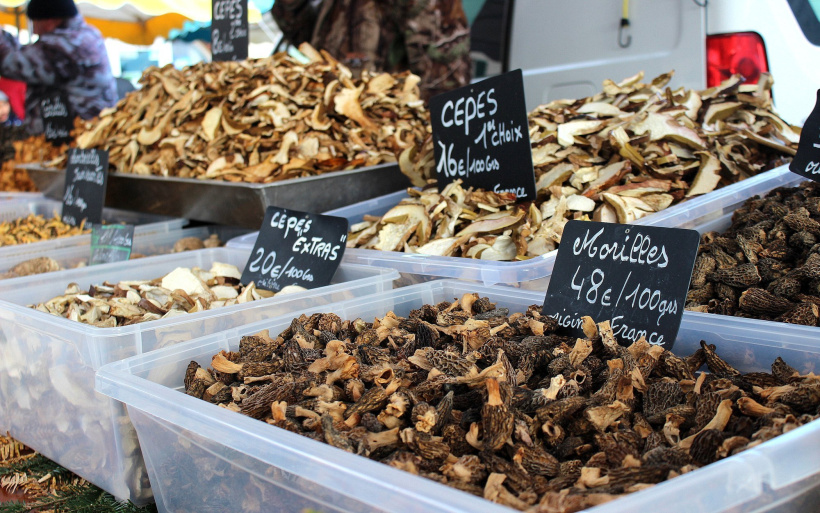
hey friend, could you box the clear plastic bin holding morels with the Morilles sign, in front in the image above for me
[96,280,820,513]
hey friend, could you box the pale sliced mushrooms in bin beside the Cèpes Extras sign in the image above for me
[31,262,304,328]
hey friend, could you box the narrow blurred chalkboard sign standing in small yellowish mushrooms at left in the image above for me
[62,148,108,226]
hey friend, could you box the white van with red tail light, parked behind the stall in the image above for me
[462,0,820,125]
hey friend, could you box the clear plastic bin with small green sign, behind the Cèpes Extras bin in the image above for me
[0,226,250,277]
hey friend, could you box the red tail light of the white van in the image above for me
[706,32,769,87]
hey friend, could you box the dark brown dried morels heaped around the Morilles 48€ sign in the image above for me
[183,294,820,513]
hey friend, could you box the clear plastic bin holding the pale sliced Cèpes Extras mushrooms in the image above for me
[0,248,398,504]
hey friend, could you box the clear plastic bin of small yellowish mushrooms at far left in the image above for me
[0,199,188,258]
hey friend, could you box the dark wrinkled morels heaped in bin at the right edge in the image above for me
[686,181,820,326]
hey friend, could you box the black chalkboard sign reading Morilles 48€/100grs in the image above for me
[543,221,700,349]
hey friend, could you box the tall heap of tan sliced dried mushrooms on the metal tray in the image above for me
[67,45,428,183]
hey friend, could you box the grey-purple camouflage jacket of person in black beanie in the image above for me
[0,15,117,134]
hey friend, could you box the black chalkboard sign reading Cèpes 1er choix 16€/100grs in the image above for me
[430,69,536,201]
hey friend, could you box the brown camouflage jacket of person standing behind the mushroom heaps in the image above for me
[271,0,471,99]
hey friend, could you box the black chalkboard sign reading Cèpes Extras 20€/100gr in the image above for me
[242,207,348,292]
